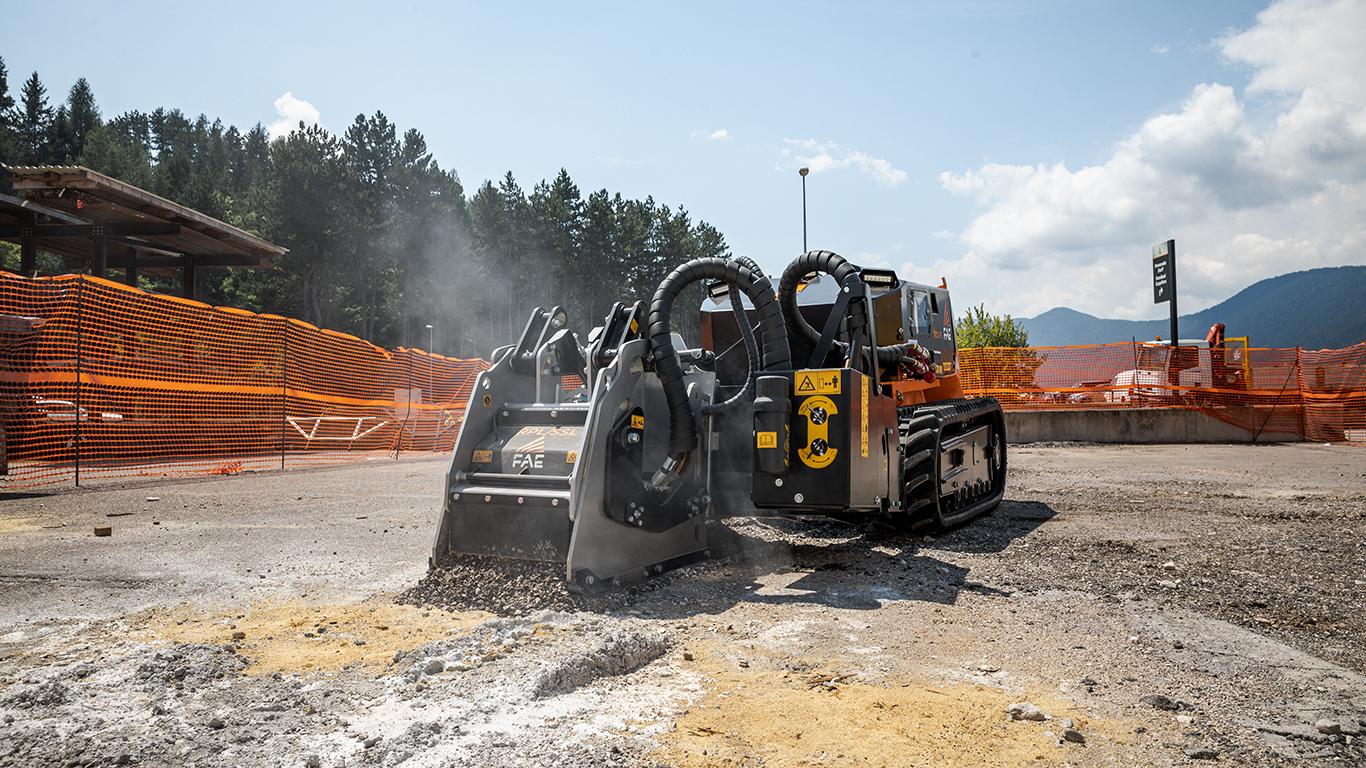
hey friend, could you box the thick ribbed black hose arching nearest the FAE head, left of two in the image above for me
[649,258,792,472]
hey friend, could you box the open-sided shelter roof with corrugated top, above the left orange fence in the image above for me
[0,165,287,298]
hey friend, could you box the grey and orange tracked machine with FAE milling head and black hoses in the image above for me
[433,250,1005,590]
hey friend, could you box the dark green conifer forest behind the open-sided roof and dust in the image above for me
[0,59,728,355]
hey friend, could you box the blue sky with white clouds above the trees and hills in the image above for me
[3,0,1366,317]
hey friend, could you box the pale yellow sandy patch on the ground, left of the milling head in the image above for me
[145,600,489,675]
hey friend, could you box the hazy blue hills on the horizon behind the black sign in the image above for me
[1020,266,1366,350]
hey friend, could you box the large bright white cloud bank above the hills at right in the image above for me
[934,0,1366,317]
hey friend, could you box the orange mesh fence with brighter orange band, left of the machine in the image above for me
[0,273,488,488]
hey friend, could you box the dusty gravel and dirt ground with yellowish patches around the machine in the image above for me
[0,444,1366,768]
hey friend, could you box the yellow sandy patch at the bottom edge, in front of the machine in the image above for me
[657,649,1143,768]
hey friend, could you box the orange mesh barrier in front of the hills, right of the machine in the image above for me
[958,340,1366,441]
